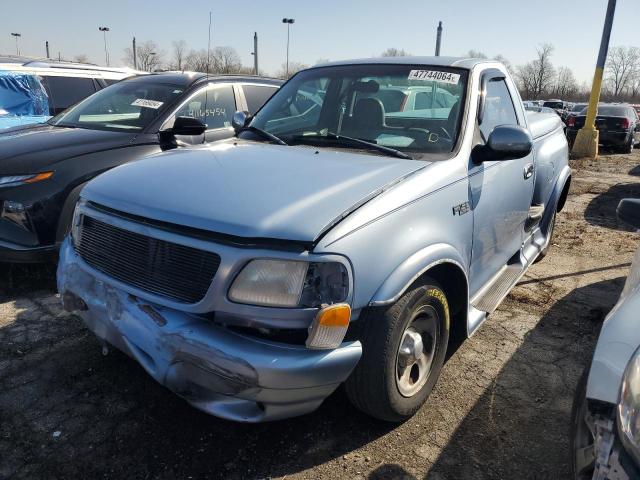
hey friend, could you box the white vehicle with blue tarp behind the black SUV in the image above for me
[0,56,143,129]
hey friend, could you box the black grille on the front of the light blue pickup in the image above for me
[76,215,220,303]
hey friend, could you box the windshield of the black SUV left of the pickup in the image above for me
[50,81,184,131]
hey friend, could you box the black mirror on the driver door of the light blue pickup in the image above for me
[472,125,533,163]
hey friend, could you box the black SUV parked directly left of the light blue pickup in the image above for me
[0,73,282,262]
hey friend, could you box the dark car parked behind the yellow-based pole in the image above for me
[567,104,640,153]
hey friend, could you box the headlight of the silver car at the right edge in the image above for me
[618,349,640,461]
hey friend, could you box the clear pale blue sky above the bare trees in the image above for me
[0,0,640,83]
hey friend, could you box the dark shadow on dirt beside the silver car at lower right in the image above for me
[418,277,624,480]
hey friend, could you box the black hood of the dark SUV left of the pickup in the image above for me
[0,124,136,175]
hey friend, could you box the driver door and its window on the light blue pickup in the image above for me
[469,70,534,293]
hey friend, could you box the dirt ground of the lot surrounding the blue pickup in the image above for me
[0,151,640,480]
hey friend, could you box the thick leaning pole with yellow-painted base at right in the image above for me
[571,0,616,158]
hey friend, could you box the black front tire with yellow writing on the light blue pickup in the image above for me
[345,279,450,422]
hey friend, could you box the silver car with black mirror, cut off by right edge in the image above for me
[571,199,640,480]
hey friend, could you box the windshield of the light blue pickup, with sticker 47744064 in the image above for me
[241,65,468,158]
